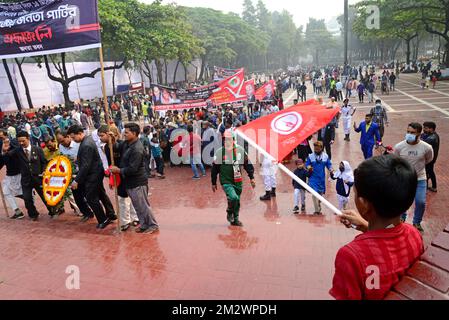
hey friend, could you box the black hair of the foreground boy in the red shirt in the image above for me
[354,155,418,219]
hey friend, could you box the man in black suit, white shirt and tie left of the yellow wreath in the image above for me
[2,131,50,221]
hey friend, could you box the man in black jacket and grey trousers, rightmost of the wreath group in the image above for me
[111,123,159,233]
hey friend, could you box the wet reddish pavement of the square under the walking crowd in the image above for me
[0,75,449,300]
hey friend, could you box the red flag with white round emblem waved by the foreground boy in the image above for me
[236,100,340,162]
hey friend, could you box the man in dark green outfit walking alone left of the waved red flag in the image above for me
[211,130,256,227]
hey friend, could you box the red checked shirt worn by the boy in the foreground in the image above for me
[329,223,424,300]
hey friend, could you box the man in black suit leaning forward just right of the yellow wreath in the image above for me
[67,125,116,229]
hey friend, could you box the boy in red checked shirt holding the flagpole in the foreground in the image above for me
[329,155,424,300]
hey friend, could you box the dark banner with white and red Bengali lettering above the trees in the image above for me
[0,0,101,59]
